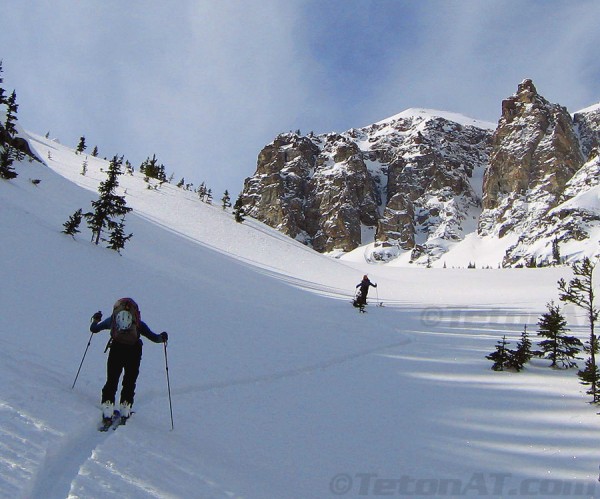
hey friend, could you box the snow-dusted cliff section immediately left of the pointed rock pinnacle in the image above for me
[372,114,491,260]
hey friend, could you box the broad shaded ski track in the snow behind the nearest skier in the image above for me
[24,420,112,499]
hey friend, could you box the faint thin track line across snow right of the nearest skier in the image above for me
[173,337,412,395]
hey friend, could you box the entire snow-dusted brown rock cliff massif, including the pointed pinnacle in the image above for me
[243,80,600,266]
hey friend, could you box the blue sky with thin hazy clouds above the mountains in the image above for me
[0,0,600,197]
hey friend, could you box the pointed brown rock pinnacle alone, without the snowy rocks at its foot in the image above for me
[479,80,583,237]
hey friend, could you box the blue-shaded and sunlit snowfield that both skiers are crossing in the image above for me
[0,136,600,499]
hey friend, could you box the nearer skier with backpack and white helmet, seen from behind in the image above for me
[90,298,169,425]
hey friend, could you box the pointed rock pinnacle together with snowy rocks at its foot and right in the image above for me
[479,80,600,266]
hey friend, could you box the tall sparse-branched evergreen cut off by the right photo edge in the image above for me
[558,257,600,403]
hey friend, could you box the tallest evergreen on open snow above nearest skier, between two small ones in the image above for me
[84,156,131,244]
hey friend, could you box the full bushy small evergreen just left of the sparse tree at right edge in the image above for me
[538,302,583,368]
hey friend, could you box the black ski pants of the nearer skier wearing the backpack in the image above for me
[102,341,142,405]
